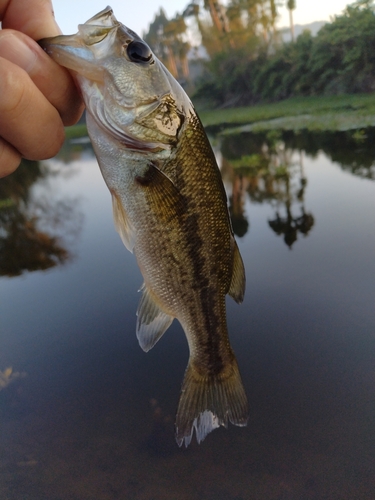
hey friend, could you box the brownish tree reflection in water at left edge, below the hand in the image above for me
[0,161,80,277]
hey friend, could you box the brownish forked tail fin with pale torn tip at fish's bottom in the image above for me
[176,358,249,447]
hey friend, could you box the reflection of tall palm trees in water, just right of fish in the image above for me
[222,131,314,248]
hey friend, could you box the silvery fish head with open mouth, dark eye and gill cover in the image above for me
[39,7,192,152]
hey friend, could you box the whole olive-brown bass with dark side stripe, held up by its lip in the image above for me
[40,7,249,447]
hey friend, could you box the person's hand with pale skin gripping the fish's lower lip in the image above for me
[0,0,83,177]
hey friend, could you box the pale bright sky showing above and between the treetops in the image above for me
[52,0,352,35]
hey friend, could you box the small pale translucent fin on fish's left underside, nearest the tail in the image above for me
[137,285,173,352]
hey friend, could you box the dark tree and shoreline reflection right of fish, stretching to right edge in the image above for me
[221,127,375,242]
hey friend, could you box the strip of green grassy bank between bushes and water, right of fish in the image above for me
[199,94,375,133]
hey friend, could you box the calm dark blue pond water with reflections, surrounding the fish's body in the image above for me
[0,129,375,500]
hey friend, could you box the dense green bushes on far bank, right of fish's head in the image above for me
[196,0,375,106]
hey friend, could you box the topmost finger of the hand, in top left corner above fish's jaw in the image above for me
[0,0,61,40]
